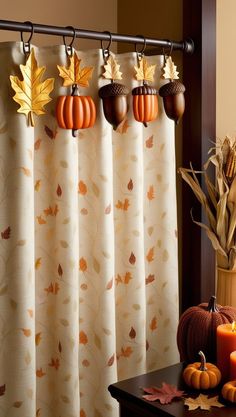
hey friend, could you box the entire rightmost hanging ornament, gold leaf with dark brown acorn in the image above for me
[159,56,185,124]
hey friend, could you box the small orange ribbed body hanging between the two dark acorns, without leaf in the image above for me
[132,84,158,126]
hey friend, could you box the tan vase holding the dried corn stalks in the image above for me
[217,267,236,307]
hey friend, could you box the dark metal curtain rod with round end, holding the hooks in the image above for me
[0,20,194,54]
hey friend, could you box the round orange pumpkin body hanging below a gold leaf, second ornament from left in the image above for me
[56,95,96,130]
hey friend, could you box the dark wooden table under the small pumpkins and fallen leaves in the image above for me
[108,364,236,417]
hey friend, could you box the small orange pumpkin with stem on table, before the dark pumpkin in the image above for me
[183,351,221,389]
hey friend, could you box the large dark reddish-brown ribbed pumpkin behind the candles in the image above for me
[177,296,236,363]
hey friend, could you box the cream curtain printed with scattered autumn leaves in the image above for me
[0,42,178,417]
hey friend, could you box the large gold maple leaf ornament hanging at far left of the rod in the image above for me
[10,48,54,126]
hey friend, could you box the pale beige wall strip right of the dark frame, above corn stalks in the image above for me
[216,0,236,139]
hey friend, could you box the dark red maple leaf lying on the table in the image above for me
[143,382,184,404]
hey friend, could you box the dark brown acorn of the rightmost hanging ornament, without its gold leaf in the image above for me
[159,81,185,124]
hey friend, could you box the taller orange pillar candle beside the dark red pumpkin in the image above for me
[216,322,236,381]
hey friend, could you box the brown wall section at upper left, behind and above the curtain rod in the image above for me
[0,0,117,49]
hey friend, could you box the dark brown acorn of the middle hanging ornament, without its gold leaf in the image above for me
[99,83,129,130]
